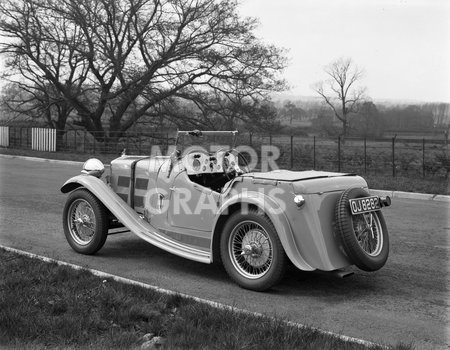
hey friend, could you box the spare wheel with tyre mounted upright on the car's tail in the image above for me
[335,188,389,271]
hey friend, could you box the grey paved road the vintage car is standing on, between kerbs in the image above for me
[0,158,450,349]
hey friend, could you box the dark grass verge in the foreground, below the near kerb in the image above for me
[0,249,412,350]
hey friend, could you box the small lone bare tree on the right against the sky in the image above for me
[314,58,365,136]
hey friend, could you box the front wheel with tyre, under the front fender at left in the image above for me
[63,188,108,254]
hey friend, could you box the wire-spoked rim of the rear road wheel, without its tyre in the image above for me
[229,221,273,279]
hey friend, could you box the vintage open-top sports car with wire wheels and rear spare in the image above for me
[61,131,390,291]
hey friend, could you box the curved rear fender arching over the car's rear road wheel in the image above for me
[213,191,315,271]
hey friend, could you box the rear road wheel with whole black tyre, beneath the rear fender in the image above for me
[220,210,287,291]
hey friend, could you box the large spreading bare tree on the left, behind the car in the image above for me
[0,0,286,140]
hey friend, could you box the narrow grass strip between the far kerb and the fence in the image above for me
[0,148,450,195]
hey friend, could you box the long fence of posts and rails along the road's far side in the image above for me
[0,127,450,178]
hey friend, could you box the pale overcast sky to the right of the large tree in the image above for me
[241,0,450,102]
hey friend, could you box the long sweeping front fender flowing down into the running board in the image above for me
[61,175,212,263]
